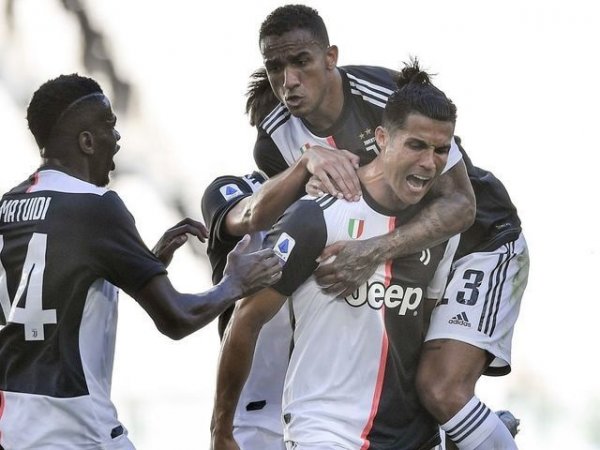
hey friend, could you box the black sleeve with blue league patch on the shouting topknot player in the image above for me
[263,199,327,296]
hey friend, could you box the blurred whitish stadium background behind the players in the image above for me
[0,0,600,450]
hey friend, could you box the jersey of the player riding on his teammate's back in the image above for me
[254,66,521,264]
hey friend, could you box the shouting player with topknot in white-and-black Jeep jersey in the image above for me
[213,63,456,450]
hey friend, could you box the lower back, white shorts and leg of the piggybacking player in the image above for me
[417,154,529,450]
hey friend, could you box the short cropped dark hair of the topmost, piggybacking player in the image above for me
[258,5,329,47]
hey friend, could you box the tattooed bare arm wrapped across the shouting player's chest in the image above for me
[315,161,475,296]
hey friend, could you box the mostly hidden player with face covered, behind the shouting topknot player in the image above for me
[202,132,358,450]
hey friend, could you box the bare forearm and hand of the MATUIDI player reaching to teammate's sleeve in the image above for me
[132,236,281,339]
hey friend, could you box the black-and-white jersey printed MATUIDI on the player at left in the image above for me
[0,168,165,449]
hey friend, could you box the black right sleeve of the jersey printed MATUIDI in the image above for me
[87,191,167,295]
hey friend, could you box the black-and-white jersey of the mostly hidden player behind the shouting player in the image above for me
[202,172,292,436]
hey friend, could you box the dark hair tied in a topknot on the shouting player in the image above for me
[382,58,456,129]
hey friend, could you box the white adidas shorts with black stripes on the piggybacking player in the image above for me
[425,234,529,375]
